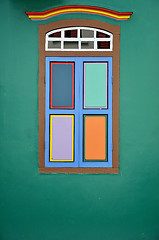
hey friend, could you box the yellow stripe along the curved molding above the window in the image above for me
[29,9,130,19]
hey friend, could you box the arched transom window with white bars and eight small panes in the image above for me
[45,27,113,51]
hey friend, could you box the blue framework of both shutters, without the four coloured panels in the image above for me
[45,57,112,168]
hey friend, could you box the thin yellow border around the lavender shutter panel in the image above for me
[50,115,74,162]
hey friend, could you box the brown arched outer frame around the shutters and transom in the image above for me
[39,19,120,174]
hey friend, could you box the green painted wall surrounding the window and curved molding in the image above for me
[0,0,159,240]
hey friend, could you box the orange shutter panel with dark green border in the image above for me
[84,115,107,161]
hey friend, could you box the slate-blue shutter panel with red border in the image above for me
[50,62,74,108]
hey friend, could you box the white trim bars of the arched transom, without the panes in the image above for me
[45,27,113,51]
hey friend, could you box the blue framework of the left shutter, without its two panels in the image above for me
[45,57,78,167]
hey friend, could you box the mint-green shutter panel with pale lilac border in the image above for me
[84,62,107,108]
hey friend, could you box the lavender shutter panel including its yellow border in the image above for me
[50,115,74,162]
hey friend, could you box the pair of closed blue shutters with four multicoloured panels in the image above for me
[45,57,112,168]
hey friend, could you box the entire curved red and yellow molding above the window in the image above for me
[26,5,133,21]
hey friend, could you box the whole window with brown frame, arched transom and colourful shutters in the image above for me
[39,20,119,173]
